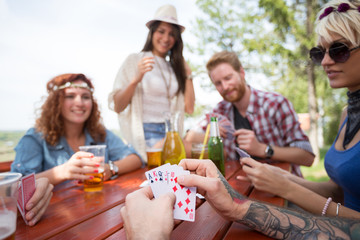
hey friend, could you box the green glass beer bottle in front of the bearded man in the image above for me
[208,117,225,176]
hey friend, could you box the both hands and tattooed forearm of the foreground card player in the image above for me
[121,159,360,239]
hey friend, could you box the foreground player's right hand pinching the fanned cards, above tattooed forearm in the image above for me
[178,159,245,221]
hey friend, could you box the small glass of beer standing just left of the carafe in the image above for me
[146,138,163,169]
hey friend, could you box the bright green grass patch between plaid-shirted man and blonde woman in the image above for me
[300,147,329,182]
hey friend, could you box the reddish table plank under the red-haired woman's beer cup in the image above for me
[15,169,146,239]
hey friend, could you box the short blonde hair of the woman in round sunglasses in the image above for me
[315,0,360,46]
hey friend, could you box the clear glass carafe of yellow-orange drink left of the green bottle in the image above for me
[161,112,186,165]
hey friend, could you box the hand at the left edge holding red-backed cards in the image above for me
[25,178,54,226]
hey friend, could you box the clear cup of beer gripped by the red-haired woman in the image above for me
[79,145,106,192]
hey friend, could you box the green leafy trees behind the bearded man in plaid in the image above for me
[190,0,350,165]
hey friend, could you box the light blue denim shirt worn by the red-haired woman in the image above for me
[11,128,141,175]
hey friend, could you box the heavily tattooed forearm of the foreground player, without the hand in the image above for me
[239,202,360,239]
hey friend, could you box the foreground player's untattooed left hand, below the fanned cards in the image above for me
[121,187,175,239]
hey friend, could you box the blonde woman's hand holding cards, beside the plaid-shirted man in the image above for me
[236,158,291,196]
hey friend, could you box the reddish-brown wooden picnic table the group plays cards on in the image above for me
[15,161,290,240]
